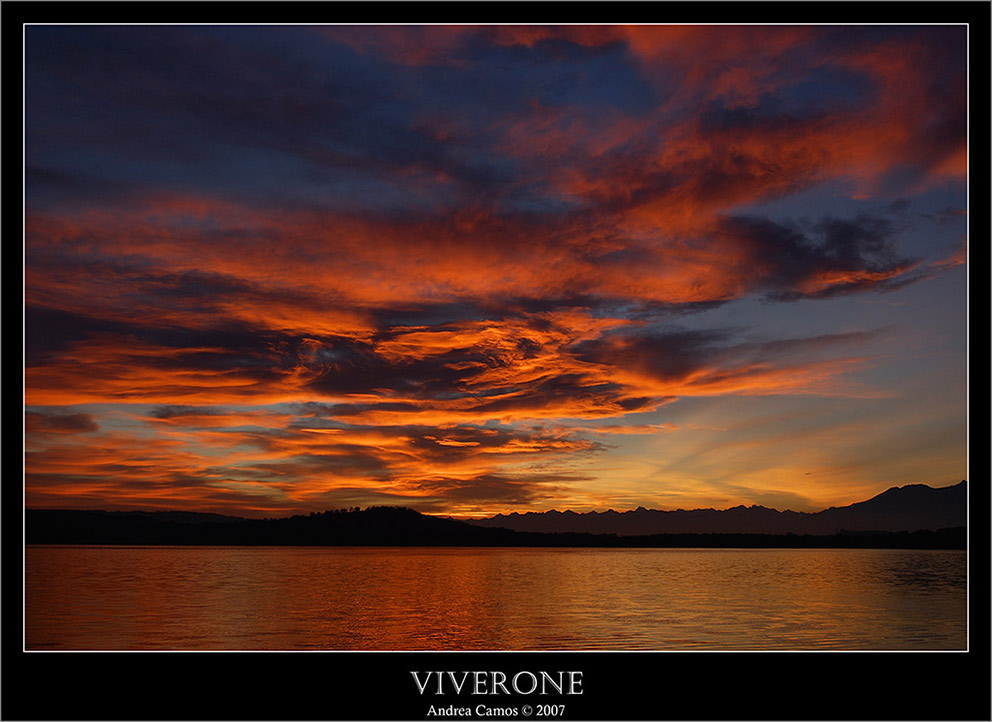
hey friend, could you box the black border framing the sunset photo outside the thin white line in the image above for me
[0,0,992,720]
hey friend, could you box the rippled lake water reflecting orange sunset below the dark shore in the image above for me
[25,546,967,650]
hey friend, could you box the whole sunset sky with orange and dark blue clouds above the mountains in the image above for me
[24,25,968,517]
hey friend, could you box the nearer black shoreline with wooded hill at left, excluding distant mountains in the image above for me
[25,506,967,549]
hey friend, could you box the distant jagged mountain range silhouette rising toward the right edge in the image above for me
[471,481,967,536]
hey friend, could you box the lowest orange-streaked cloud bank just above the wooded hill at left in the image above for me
[25,394,603,509]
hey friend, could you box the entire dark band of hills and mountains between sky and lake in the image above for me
[25,482,967,548]
